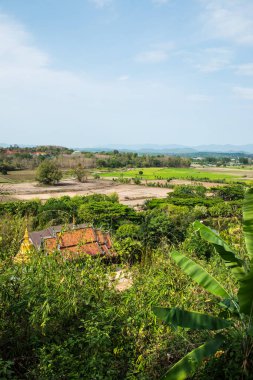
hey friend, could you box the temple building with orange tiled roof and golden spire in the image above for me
[14,224,114,262]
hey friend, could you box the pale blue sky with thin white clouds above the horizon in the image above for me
[0,0,253,147]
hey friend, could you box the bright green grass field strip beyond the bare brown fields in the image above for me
[99,168,243,182]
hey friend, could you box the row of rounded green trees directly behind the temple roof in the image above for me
[0,193,138,230]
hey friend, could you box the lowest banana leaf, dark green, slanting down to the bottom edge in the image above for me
[162,334,224,380]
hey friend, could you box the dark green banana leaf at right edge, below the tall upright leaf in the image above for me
[238,263,253,317]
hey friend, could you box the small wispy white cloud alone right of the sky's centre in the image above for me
[135,42,174,63]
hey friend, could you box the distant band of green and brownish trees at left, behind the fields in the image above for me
[0,147,191,174]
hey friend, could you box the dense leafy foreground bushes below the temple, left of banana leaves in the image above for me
[0,252,215,380]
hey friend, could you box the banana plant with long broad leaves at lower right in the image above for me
[153,188,253,380]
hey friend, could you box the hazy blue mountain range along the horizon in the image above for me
[0,143,253,155]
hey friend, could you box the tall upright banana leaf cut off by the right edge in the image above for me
[242,188,253,259]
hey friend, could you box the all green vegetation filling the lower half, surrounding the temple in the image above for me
[0,183,253,380]
